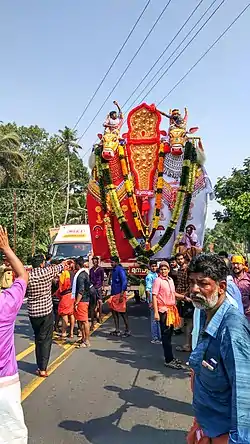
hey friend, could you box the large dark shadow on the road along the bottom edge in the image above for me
[59,406,186,444]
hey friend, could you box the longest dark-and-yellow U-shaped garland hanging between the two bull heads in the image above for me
[95,142,193,262]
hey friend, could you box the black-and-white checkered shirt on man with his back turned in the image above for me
[26,265,64,318]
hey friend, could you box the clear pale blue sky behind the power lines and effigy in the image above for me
[0,0,250,227]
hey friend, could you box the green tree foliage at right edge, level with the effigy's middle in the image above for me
[215,158,250,242]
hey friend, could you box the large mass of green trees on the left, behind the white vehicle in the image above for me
[0,123,89,261]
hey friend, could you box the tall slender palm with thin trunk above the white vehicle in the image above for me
[56,126,81,224]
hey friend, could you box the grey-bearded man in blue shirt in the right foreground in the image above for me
[188,254,250,444]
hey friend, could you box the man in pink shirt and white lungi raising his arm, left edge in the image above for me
[0,225,28,444]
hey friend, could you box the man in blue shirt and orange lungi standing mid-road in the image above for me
[108,256,130,337]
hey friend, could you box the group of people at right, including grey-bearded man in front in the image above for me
[146,252,250,444]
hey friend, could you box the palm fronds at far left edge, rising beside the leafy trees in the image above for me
[0,128,24,181]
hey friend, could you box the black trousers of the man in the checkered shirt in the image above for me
[30,312,54,370]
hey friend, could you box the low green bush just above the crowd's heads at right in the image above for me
[203,222,243,254]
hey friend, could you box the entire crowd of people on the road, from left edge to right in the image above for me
[0,222,250,444]
